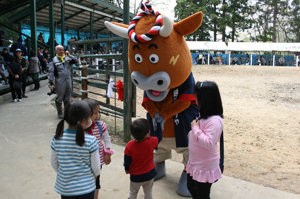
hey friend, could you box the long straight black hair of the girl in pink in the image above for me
[194,81,223,119]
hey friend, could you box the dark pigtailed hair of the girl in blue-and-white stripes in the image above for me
[54,100,91,146]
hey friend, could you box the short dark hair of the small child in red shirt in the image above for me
[130,118,150,141]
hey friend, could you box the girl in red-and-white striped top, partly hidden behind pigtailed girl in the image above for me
[85,99,113,199]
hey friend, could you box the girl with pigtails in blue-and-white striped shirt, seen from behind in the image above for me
[51,100,101,199]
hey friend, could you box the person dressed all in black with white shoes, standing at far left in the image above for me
[7,55,23,102]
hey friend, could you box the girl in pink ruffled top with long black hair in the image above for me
[186,81,223,199]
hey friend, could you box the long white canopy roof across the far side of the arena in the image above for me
[187,41,300,52]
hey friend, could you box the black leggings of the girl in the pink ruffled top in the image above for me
[187,174,212,199]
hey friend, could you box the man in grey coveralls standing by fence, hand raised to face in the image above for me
[48,45,78,119]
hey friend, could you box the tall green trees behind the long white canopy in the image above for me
[175,0,300,42]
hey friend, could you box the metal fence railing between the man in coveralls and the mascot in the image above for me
[71,54,136,141]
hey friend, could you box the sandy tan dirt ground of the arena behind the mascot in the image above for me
[93,65,300,194]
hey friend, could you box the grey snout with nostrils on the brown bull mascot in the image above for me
[131,71,171,91]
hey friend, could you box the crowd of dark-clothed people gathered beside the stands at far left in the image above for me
[0,33,50,102]
